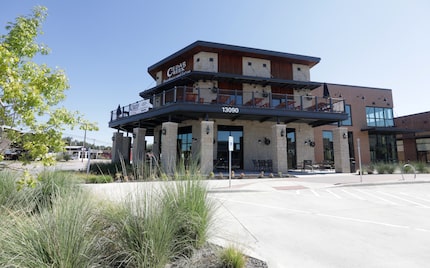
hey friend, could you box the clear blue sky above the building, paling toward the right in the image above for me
[0,0,430,146]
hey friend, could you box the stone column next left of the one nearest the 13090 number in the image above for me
[161,122,178,174]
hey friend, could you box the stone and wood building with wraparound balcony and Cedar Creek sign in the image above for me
[109,41,350,173]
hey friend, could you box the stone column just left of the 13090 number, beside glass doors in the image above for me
[200,121,214,175]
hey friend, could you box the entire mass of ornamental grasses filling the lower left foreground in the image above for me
[0,168,213,268]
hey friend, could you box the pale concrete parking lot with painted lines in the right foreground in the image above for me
[210,175,430,267]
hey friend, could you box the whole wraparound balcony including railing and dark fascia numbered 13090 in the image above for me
[109,87,346,132]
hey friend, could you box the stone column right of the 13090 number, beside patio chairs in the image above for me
[272,124,288,173]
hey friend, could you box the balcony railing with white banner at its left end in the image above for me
[111,87,345,121]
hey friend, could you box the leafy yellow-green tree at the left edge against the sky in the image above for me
[0,6,98,164]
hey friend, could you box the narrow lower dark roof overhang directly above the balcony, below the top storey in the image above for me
[139,71,322,98]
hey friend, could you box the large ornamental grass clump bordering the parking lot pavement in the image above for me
[102,175,212,268]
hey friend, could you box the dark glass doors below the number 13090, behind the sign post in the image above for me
[215,126,243,169]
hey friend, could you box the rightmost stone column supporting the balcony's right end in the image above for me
[333,127,351,173]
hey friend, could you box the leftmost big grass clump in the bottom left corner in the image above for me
[0,187,103,267]
